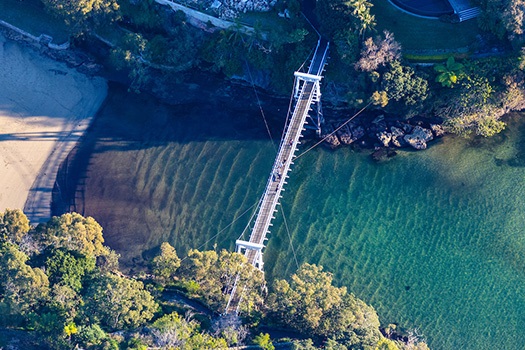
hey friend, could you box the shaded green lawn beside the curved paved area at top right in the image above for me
[371,0,479,52]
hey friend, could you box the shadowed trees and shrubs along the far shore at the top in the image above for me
[30,0,525,136]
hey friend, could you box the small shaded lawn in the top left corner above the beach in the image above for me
[0,0,69,44]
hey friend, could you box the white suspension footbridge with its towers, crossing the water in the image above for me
[225,39,330,314]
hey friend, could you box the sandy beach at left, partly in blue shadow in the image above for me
[0,35,107,224]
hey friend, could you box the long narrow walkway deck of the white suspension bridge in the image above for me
[226,40,328,313]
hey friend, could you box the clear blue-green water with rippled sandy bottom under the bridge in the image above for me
[77,81,525,349]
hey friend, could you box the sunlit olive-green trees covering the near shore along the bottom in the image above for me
[0,210,428,349]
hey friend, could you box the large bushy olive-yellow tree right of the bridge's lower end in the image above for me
[267,264,381,346]
